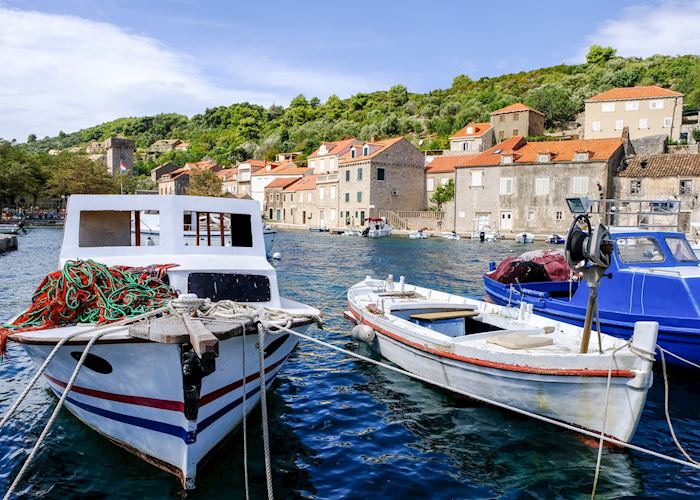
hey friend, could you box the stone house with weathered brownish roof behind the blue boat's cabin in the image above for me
[615,154,700,236]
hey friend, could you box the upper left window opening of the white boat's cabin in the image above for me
[78,210,160,248]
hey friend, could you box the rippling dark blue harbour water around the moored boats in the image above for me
[0,229,700,498]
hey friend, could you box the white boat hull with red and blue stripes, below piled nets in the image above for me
[24,326,307,489]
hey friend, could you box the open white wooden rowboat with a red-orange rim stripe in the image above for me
[346,277,658,441]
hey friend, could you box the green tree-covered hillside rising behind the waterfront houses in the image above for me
[24,50,700,172]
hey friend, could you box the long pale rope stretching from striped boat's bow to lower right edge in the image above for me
[269,324,700,470]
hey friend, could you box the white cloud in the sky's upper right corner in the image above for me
[574,0,700,62]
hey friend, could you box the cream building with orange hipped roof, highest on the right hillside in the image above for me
[583,86,683,141]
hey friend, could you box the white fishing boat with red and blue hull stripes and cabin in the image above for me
[3,195,319,489]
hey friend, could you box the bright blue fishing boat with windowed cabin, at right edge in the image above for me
[483,198,700,366]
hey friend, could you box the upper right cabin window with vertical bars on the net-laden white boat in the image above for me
[182,211,253,248]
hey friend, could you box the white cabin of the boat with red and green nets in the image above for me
[60,195,280,307]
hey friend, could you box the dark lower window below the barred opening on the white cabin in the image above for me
[187,273,271,302]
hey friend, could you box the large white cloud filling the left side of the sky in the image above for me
[0,6,386,141]
